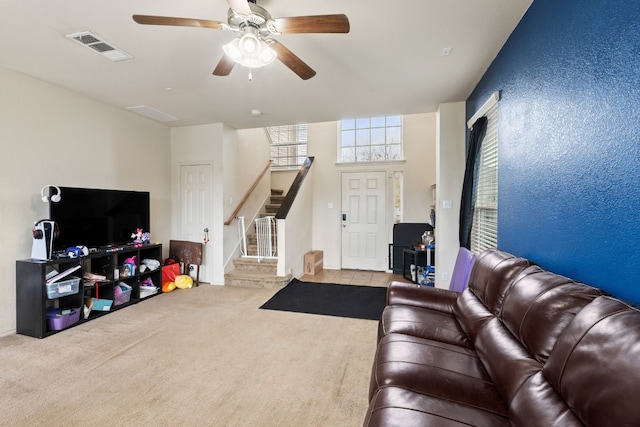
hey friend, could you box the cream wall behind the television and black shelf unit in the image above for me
[0,67,171,335]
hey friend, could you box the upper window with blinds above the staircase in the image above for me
[266,123,307,170]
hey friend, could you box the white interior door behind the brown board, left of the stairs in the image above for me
[180,164,213,282]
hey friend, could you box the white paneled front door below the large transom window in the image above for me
[342,172,387,271]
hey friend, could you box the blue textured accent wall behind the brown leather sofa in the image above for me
[467,0,640,305]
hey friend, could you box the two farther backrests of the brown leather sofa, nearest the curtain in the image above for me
[454,250,601,410]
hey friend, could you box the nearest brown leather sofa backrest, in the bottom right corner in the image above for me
[509,296,640,427]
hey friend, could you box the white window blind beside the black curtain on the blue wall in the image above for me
[471,102,498,253]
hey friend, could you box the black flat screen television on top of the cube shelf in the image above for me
[49,187,151,251]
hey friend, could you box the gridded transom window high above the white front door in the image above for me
[338,116,402,163]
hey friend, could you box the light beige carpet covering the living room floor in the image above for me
[0,276,400,427]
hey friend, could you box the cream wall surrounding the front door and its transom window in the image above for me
[308,113,438,269]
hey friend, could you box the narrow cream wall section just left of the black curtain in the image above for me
[436,102,465,288]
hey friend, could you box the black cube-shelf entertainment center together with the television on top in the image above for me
[16,187,162,338]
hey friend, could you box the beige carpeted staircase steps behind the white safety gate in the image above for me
[224,189,291,289]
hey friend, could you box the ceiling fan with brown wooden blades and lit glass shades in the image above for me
[133,0,350,80]
